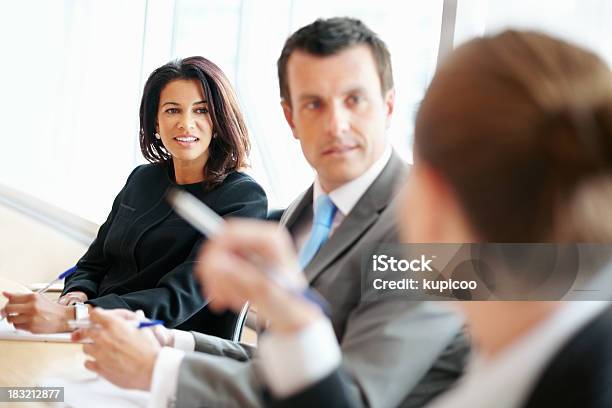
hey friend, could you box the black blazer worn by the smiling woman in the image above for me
[63,164,268,337]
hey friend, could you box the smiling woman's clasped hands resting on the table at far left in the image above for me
[1,292,74,333]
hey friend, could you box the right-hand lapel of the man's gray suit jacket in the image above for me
[302,152,407,283]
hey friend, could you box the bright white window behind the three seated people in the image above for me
[0,0,612,223]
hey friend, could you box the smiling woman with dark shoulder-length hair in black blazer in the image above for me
[4,57,267,337]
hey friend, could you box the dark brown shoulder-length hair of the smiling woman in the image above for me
[140,57,250,189]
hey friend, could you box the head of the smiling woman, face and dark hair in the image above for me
[140,57,250,188]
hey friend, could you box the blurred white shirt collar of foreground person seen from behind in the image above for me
[428,301,610,408]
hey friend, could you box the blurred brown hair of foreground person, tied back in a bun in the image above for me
[415,31,612,242]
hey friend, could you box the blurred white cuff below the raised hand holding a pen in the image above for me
[258,319,342,398]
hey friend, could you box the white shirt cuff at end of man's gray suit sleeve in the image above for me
[149,348,185,408]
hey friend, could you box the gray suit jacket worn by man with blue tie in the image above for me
[176,154,468,407]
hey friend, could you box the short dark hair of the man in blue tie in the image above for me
[277,17,393,103]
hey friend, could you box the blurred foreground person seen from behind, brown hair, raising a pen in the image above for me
[198,31,612,408]
